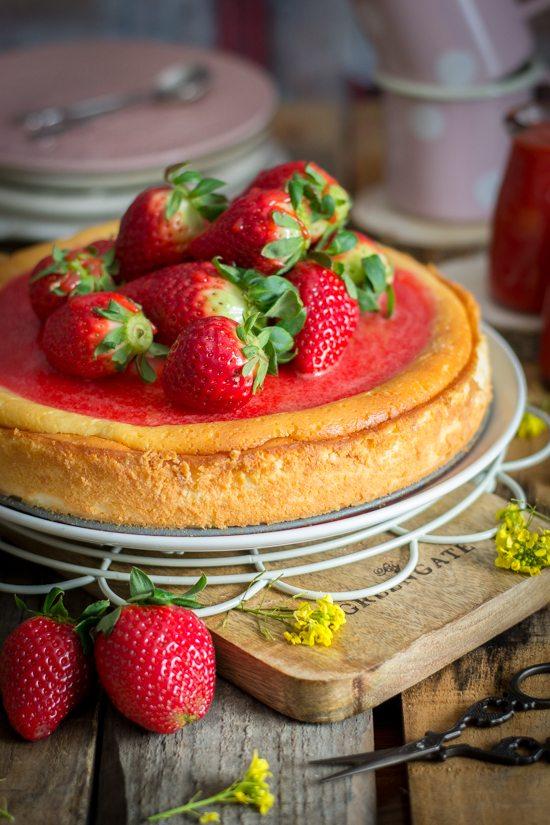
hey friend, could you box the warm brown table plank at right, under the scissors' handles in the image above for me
[402,608,550,825]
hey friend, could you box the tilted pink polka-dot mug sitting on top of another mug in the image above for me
[355,0,550,87]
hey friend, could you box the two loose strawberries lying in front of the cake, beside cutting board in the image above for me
[0,568,216,741]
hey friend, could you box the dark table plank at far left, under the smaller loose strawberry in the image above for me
[0,568,99,825]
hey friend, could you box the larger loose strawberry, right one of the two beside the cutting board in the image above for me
[95,568,216,733]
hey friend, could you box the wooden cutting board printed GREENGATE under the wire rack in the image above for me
[2,492,550,722]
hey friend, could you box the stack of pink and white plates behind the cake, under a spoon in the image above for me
[0,41,284,240]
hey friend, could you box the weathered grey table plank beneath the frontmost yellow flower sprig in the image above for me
[95,679,375,825]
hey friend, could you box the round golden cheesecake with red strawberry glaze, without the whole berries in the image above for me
[0,224,491,528]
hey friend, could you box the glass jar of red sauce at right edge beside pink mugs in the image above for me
[490,103,550,314]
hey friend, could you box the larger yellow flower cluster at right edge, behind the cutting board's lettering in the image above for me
[495,502,550,576]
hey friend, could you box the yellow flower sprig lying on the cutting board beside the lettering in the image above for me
[235,596,346,647]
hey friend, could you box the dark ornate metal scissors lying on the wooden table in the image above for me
[309,662,550,782]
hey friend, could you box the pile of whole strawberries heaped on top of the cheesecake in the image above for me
[30,161,393,412]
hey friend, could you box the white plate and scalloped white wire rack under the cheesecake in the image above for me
[0,320,550,616]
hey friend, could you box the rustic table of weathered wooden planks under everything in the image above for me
[0,104,550,825]
